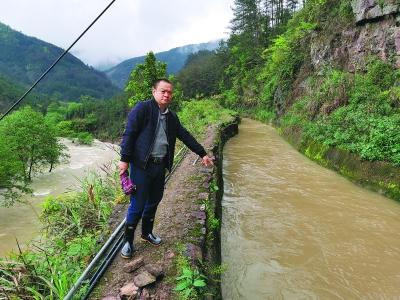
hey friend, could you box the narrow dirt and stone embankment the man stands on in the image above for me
[91,120,238,300]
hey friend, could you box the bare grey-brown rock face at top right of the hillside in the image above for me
[311,0,400,71]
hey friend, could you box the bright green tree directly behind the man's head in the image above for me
[125,52,167,106]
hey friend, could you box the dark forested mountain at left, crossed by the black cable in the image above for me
[0,23,119,100]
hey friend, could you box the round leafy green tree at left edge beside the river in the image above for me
[0,106,66,203]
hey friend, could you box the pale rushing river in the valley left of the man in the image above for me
[0,140,118,257]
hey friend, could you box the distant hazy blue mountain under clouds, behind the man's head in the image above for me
[105,40,220,88]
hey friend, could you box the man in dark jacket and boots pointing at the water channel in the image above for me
[119,79,213,258]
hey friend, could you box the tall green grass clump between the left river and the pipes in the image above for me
[0,167,122,299]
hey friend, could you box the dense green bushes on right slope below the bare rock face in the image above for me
[298,60,400,165]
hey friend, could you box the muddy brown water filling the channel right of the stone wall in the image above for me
[221,119,400,300]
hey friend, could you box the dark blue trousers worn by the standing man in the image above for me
[126,162,166,224]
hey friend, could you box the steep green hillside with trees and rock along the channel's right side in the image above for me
[177,0,400,199]
